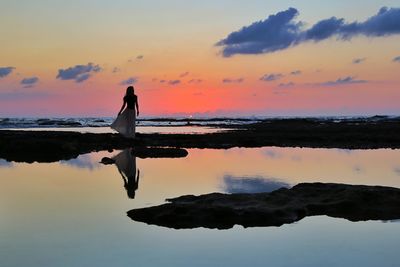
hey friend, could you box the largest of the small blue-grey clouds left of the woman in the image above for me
[56,63,102,83]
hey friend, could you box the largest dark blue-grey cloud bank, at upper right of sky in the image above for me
[216,7,400,57]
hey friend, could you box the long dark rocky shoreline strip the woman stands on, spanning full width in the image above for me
[0,119,400,162]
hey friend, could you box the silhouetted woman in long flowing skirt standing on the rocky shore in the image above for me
[111,86,139,138]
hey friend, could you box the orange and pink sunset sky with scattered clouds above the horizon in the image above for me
[0,0,400,117]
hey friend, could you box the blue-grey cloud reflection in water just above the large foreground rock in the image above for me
[222,175,290,194]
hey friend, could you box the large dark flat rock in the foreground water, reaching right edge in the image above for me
[128,183,400,229]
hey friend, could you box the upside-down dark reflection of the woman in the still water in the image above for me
[113,148,140,198]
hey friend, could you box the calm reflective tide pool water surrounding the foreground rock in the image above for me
[0,147,400,267]
